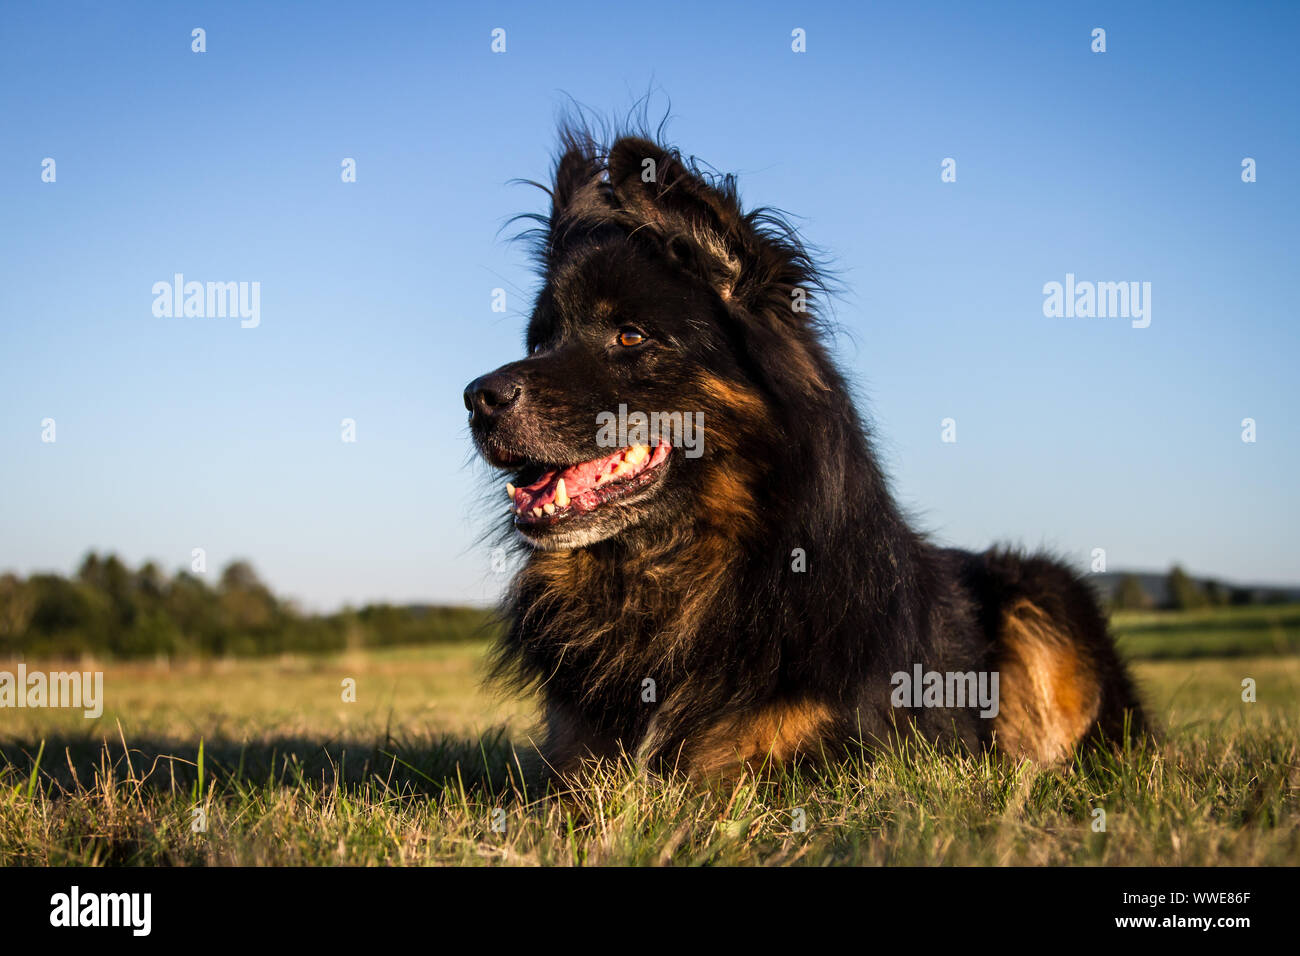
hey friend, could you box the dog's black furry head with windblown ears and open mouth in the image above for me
[464,133,835,550]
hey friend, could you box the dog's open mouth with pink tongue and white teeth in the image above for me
[506,442,672,527]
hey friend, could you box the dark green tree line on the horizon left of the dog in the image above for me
[0,551,491,658]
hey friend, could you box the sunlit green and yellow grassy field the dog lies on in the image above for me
[0,607,1300,865]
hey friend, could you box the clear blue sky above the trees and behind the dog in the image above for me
[0,3,1300,609]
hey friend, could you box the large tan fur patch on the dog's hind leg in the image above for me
[993,601,1101,763]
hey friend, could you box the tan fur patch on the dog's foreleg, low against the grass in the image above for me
[683,701,831,777]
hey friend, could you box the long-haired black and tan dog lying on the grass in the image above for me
[464,129,1145,775]
